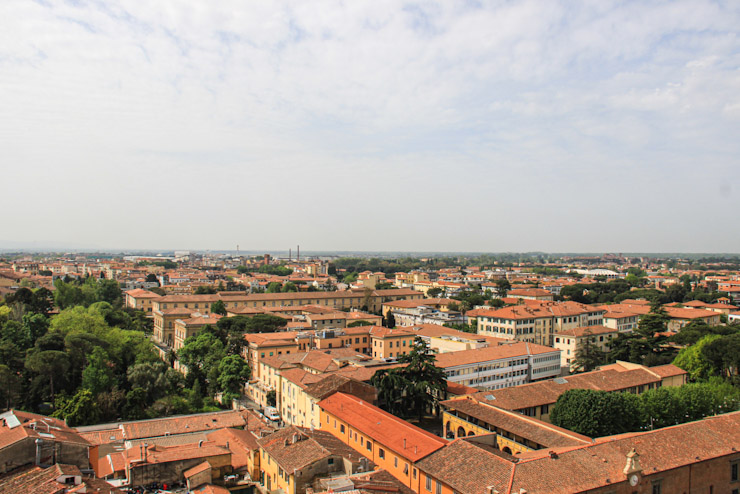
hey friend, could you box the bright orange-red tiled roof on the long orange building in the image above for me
[319,393,447,461]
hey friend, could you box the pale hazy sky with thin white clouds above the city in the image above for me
[0,0,740,253]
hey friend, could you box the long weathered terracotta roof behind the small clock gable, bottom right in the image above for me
[417,412,740,494]
